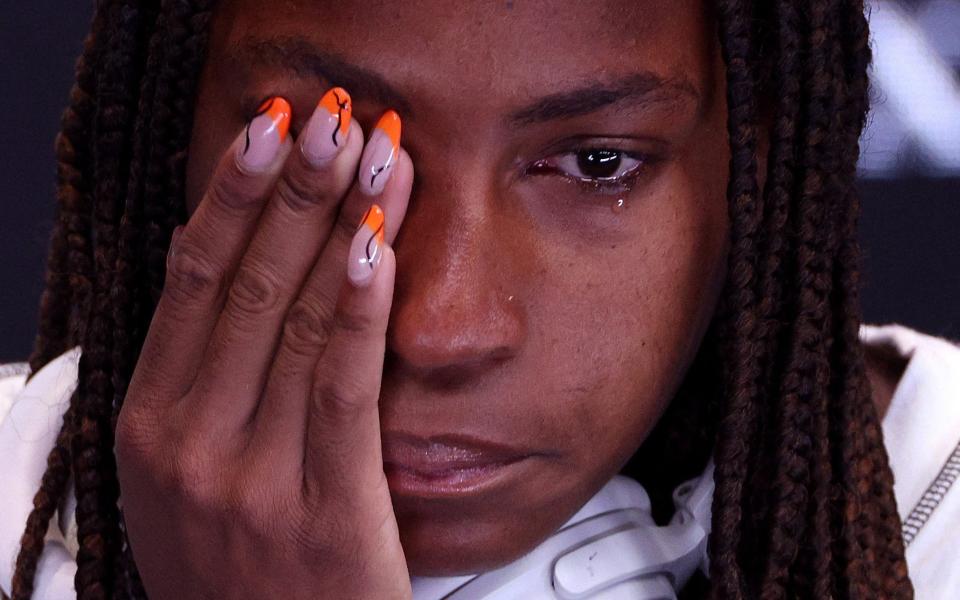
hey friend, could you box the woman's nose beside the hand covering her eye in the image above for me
[387,169,526,388]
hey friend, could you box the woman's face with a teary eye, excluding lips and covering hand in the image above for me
[187,0,729,575]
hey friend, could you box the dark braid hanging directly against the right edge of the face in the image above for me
[709,1,761,598]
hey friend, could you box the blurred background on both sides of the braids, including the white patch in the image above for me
[0,0,960,362]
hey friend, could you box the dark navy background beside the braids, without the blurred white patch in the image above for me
[0,0,960,362]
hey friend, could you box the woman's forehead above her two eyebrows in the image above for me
[212,0,715,105]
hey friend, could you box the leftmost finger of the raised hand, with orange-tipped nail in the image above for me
[130,98,291,404]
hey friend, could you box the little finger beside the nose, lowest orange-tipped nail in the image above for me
[306,234,396,498]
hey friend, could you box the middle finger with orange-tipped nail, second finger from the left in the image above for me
[194,88,363,430]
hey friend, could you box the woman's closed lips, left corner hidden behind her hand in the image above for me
[383,433,537,499]
